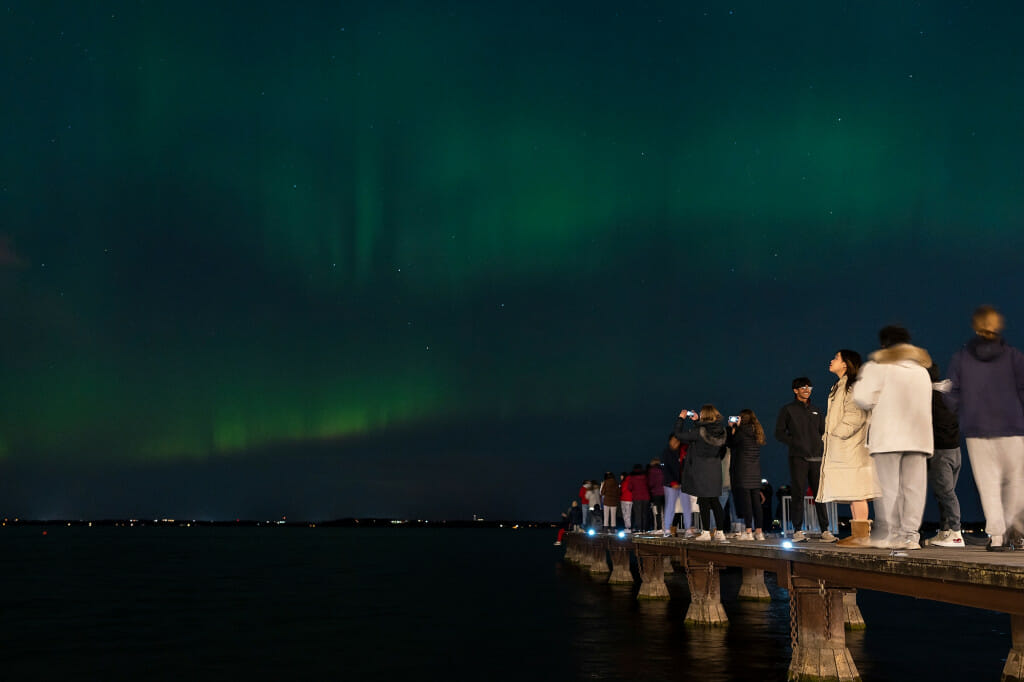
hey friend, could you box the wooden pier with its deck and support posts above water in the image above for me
[563,532,1024,682]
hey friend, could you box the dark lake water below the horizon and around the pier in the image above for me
[0,527,1011,682]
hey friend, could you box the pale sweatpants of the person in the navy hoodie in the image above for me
[967,436,1024,536]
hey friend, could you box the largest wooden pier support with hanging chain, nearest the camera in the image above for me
[786,578,860,682]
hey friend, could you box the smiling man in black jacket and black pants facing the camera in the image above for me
[775,377,828,542]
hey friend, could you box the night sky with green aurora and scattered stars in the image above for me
[0,0,1024,520]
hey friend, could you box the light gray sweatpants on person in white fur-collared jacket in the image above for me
[871,453,928,542]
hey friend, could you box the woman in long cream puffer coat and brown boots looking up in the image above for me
[815,349,882,547]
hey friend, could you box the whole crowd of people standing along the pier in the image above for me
[555,305,1024,552]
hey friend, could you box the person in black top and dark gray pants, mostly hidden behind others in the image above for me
[925,364,964,548]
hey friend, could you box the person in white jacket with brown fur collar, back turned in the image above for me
[853,326,934,550]
